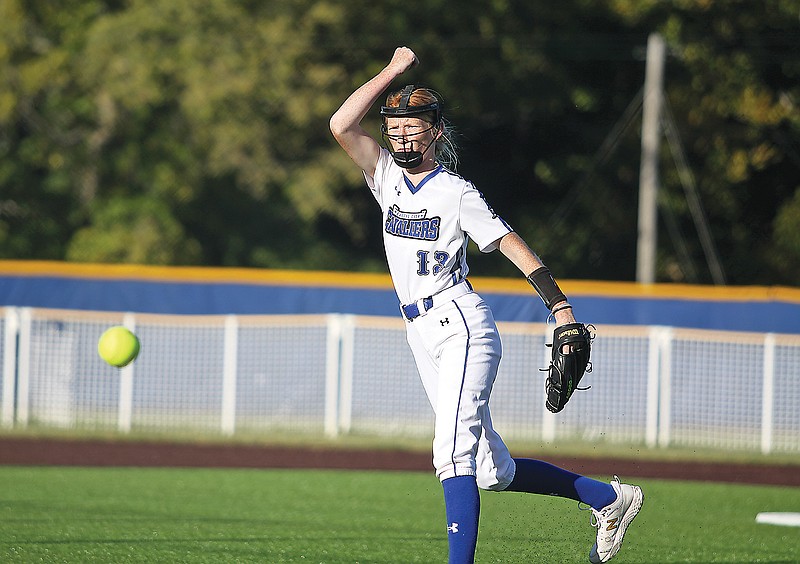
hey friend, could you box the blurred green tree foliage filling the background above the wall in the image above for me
[0,0,800,284]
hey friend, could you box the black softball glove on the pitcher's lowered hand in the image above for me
[542,323,594,413]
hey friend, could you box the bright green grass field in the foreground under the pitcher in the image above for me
[0,467,800,564]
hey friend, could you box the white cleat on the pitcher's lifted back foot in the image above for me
[589,476,644,564]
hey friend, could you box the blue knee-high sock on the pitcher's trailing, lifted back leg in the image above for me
[505,458,617,509]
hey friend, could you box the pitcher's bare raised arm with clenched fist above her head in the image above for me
[330,47,419,176]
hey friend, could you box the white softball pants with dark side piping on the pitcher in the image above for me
[406,292,516,490]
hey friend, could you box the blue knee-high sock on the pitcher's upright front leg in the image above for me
[442,476,481,564]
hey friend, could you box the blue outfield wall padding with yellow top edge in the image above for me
[0,261,800,334]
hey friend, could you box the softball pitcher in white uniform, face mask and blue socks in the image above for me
[330,47,643,564]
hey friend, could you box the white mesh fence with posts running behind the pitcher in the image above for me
[0,308,800,453]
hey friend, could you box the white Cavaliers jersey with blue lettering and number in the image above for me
[365,148,512,304]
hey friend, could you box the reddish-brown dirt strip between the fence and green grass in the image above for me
[0,438,800,486]
